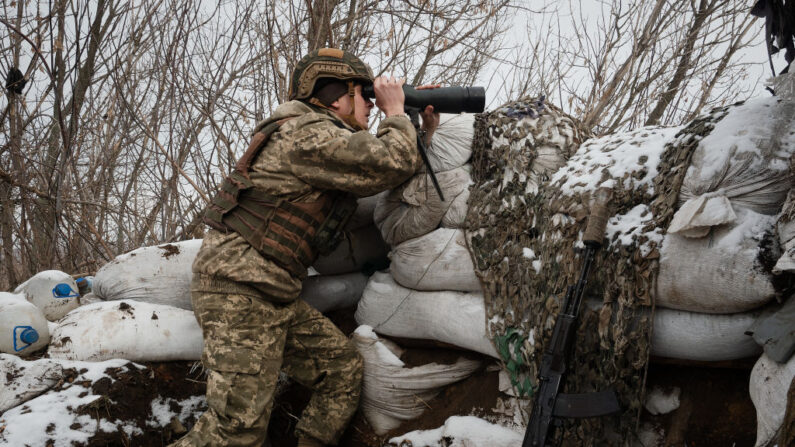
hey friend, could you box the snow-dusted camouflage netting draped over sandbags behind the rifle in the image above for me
[466,99,728,446]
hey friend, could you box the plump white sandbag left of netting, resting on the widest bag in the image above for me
[389,228,481,292]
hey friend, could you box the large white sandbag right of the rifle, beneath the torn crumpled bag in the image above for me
[654,208,777,314]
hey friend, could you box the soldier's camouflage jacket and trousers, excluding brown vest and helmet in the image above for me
[173,101,420,446]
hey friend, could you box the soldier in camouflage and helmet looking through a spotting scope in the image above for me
[172,48,439,447]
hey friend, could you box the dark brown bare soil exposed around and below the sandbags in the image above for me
[23,312,756,447]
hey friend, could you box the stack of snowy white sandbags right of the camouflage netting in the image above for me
[652,98,795,360]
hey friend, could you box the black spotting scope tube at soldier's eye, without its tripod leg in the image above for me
[362,84,486,113]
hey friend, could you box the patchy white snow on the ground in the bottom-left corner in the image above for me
[0,359,143,447]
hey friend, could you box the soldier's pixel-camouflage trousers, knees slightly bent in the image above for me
[172,275,363,447]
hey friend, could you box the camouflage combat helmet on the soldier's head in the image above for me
[288,48,373,99]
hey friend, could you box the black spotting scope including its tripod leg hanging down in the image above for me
[362,85,486,202]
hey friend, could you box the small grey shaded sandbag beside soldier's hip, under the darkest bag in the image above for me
[299,272,370,313]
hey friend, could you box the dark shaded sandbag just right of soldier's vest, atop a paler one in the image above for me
[312,225,389,275]
